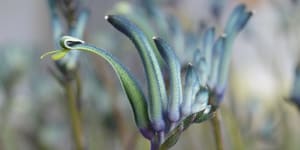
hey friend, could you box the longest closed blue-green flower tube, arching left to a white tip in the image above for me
[105,15,167,132]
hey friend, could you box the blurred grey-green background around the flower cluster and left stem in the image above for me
[0,0,300,150]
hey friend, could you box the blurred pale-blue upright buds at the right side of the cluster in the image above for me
[193,4,253,108]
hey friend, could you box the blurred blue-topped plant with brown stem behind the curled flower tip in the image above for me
[48,0,88,150]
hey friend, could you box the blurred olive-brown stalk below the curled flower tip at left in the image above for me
[65,81,83,150]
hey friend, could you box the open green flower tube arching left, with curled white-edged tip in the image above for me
[41,36,153,138]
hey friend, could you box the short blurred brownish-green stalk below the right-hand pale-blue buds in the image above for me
[210,110,224,150]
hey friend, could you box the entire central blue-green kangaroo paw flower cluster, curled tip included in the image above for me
[42,5,252,149]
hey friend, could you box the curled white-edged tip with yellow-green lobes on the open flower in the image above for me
[40,36,84,60]
